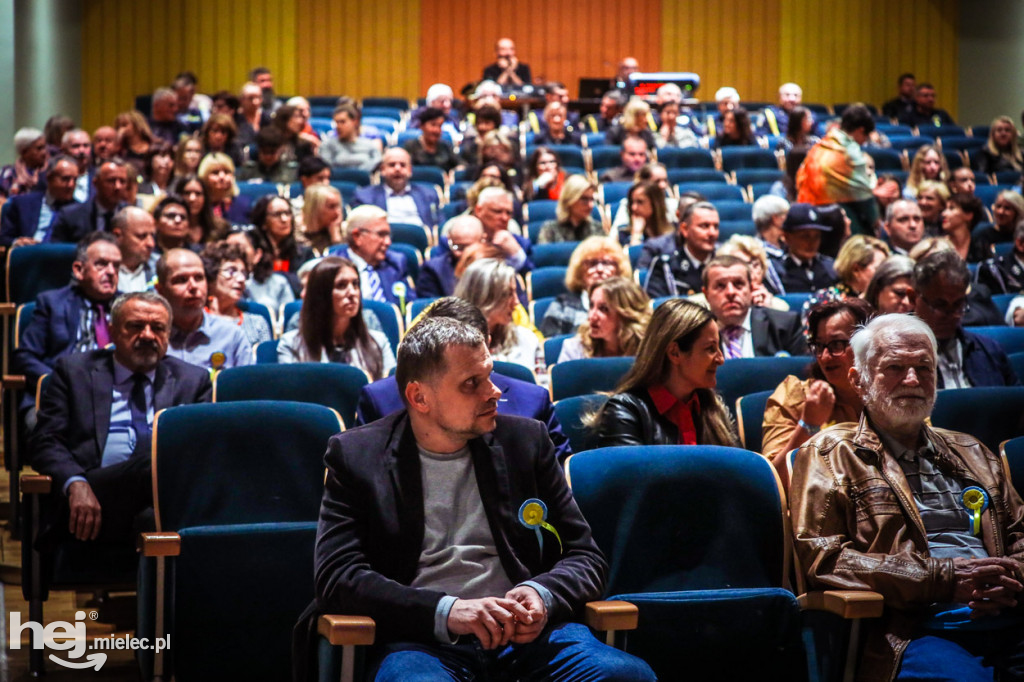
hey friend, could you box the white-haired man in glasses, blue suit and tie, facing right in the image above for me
[332,205,416,306]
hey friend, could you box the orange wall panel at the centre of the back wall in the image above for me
[419,0,662,97]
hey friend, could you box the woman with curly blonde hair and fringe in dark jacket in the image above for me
[540,237,633,337]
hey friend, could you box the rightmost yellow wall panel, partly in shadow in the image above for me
[779,0,959,118]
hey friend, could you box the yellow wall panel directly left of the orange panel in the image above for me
[296,0,421,97]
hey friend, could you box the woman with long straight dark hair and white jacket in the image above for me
[278,256,395,381]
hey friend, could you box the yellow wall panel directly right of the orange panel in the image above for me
[662,0,782,106]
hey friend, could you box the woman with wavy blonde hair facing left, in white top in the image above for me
[557,278,650,363]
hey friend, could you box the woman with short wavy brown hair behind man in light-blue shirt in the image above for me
[200,242,273,345]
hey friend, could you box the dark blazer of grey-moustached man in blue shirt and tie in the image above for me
[30,349,213,489]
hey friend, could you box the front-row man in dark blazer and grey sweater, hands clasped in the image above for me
[297,319,654,681]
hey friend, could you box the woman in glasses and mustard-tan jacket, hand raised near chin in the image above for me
[761,298,874,487]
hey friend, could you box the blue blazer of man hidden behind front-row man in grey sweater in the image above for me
[355,372,572,463]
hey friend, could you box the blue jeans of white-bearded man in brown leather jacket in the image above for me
[896,628,1024,682]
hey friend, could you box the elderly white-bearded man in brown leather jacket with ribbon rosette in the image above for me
[791,314,1024,681]
